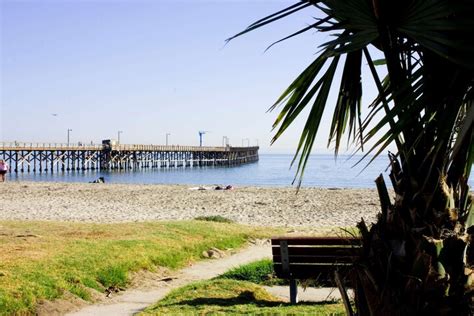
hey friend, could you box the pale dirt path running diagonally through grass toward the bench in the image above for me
[67,244,271,316]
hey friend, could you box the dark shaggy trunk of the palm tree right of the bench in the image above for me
[354,4,474,315]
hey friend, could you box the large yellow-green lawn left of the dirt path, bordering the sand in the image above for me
[0,221,278,314]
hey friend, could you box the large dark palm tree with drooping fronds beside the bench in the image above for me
[231,0,474,315]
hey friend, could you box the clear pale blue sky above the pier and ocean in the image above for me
[0,0,382,153]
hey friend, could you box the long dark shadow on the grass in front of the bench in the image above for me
[162,291,335,307]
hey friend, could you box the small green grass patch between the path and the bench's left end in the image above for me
[217,259,289,285]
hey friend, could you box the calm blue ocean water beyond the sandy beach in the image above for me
[9,154,474,188]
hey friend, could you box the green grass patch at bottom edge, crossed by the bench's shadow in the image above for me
[139,279,345,316]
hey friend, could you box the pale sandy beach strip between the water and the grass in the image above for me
[0,182,379,228]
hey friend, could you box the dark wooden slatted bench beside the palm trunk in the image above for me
[272,237,361,304]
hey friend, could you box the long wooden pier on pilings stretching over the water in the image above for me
[0,141,259,173]
